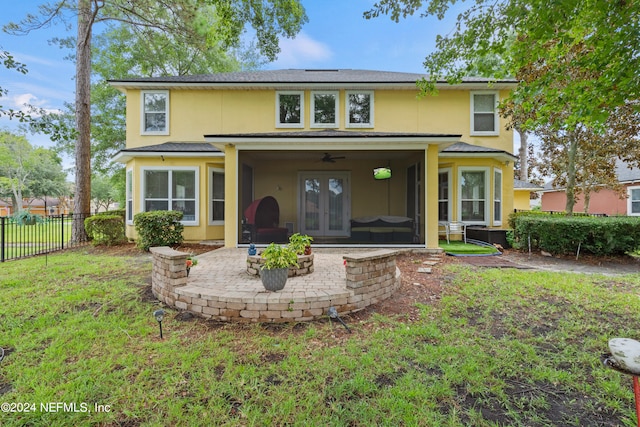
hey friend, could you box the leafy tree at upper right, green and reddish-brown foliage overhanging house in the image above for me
[365,0,640,213]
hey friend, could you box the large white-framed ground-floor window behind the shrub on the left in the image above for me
[142,167,199,225]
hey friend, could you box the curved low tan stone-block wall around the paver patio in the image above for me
[150,247,401,322]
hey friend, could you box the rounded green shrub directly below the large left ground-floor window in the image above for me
[133,211,184,251]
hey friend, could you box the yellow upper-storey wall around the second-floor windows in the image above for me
[126,89,513,152]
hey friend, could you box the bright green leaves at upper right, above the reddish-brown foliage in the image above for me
[365,0,640,128]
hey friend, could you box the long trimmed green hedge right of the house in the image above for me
[509,213,640,256]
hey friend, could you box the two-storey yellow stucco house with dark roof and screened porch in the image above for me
[110,70,515,248]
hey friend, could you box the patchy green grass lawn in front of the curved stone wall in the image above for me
[0,248,640,427]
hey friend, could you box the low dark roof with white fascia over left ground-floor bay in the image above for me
[113,142,224,163]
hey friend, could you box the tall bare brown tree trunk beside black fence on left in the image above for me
[71,0,92,242]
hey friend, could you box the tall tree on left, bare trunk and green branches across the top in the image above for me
[4,0,306,241]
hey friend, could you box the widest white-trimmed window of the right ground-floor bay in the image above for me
[458,168,489,225]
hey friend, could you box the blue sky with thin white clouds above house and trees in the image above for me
[0,0,456,154]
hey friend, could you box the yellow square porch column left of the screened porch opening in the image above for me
[224,144,240,248]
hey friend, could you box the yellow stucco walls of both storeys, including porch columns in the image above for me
[121,83,516,248]
